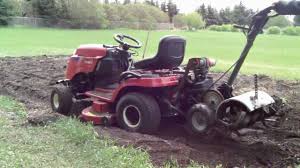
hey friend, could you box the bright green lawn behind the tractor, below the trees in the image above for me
[0,28,300,79]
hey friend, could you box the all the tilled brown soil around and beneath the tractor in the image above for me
[0,56,300,167]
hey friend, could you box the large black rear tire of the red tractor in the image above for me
[116,93,161,134]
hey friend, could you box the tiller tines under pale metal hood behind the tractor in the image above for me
[217,91,281,130]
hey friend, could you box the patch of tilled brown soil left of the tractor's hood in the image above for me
[0,56,66,109]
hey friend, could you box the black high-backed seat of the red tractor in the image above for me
[134,36,186,70]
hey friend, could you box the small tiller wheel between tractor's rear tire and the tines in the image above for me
[186,104,215,135]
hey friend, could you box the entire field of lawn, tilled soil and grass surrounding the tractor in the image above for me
[0,28,300,168]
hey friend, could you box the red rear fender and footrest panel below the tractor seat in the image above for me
[85,75,179,103]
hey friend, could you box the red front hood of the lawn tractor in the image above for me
[66,45,107,80]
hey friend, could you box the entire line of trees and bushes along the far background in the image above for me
[0,0,300,29]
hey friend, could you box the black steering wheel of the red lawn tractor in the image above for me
[114,34,142,50]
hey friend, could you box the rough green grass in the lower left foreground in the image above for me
[0,96,153,168]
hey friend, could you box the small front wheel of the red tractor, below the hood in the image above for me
[50,86,73,115]
